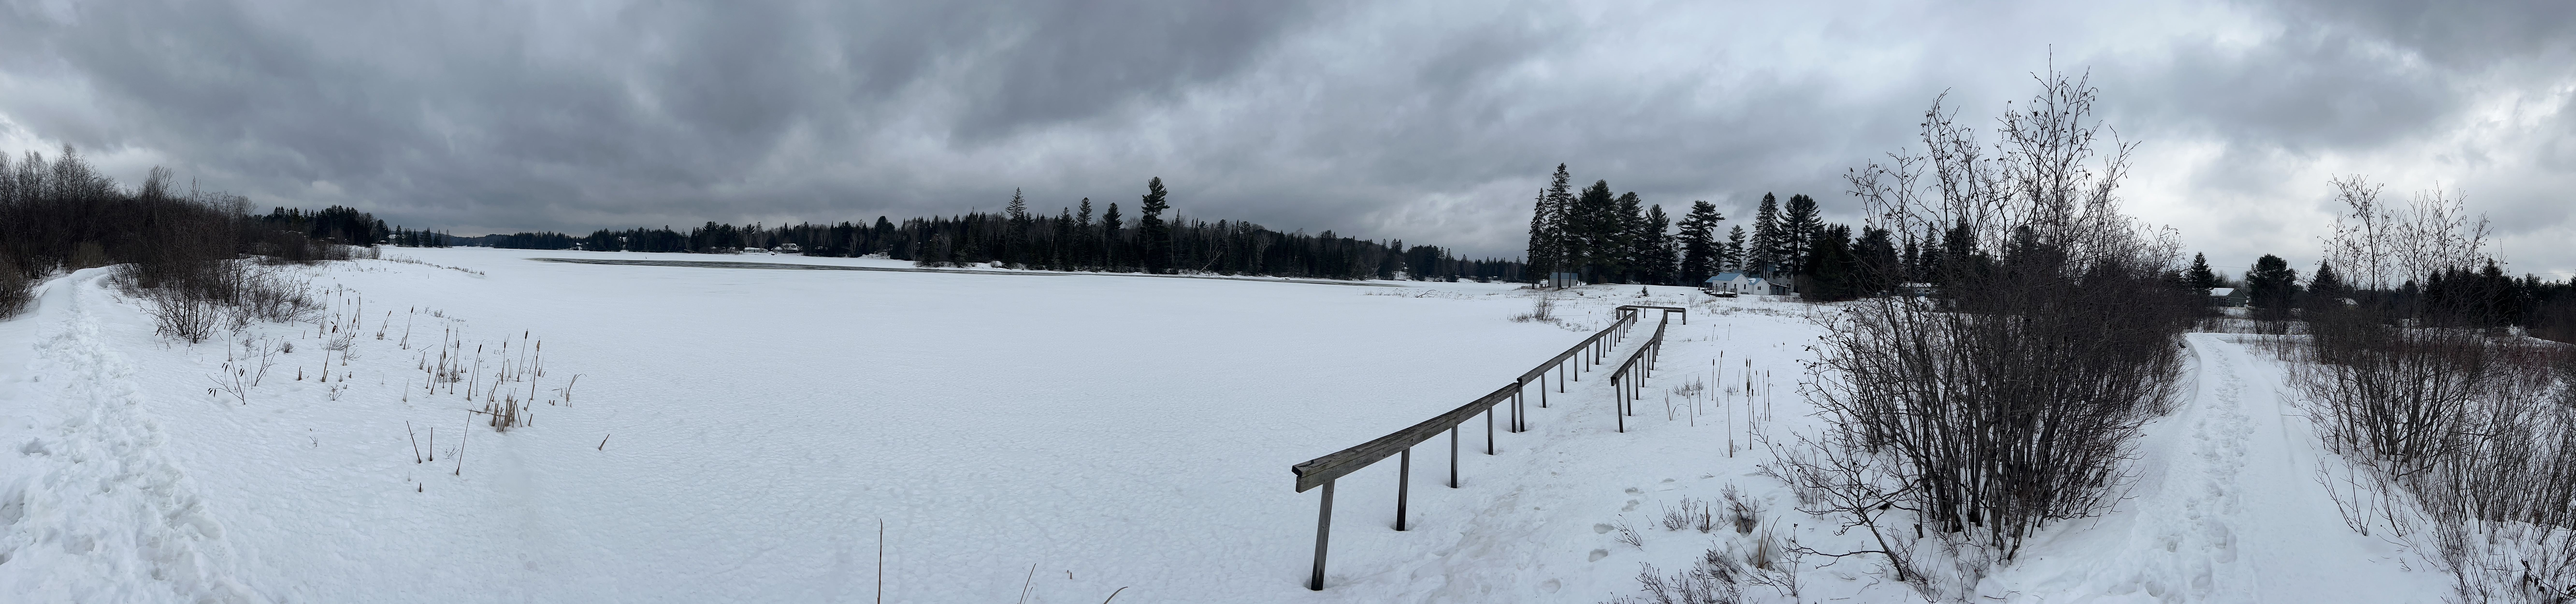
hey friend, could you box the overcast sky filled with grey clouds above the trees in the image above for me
[0,0,2576,279]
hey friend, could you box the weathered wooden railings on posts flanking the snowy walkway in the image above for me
[1288,305,1690,591]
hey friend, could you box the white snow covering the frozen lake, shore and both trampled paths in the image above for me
[0,248,2447,601]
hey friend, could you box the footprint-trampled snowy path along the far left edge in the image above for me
[0,268,260,601]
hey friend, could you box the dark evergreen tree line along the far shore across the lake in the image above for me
[482,178,1525,281]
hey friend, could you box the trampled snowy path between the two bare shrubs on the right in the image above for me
[1981,333,2445,601]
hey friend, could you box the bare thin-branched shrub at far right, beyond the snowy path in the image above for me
[2290,175,2576,601]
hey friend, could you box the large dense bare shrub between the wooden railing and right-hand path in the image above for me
[1803,72,2200,591]
